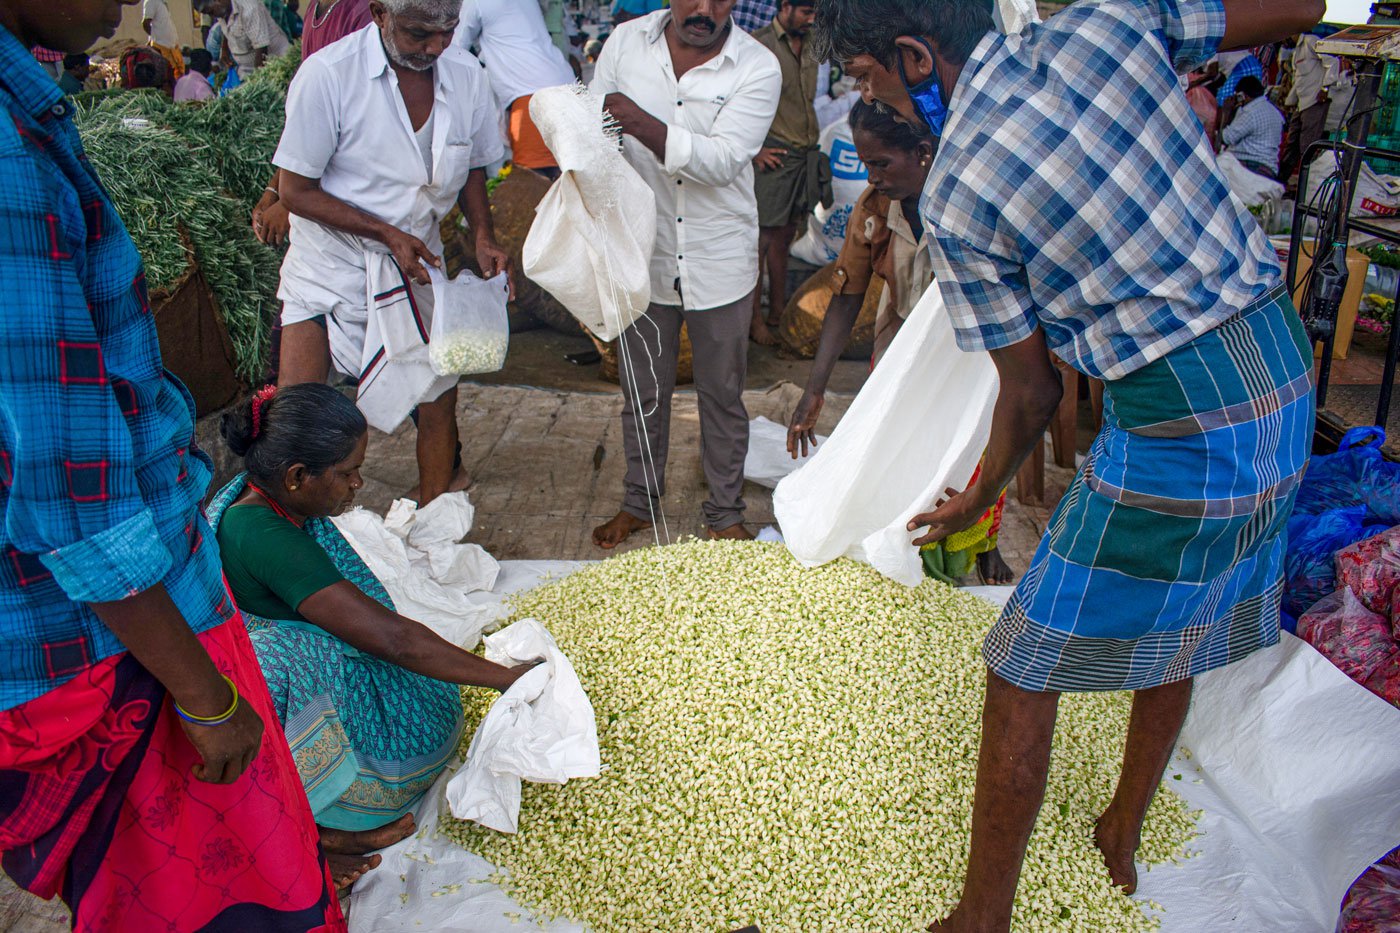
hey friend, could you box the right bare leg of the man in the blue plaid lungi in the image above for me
[1093,679,1191,894]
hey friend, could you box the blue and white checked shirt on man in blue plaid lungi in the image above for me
[921,0,1280,380]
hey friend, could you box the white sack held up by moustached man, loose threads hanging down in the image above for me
[522,85,657,340]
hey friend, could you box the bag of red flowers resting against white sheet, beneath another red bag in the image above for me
[1298,587,1400,706]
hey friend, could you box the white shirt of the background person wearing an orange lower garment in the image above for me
[452,0,574,109]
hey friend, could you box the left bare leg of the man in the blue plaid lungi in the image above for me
[928,670,1060,933]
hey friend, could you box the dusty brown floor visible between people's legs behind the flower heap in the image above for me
[0,331,1082,933]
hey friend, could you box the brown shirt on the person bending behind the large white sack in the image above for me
[832,188,934,361]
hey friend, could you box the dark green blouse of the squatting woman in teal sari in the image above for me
[217,503,344,622]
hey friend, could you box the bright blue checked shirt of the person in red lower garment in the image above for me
[0,28,234,709]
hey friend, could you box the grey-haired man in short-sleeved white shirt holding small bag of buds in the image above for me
[273,0,508,504]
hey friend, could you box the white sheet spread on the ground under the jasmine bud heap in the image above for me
[350,562,1400,933]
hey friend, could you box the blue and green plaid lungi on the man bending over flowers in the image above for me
[983,286,1313,691]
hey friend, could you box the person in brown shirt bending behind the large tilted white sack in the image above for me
[787,101,1015,586]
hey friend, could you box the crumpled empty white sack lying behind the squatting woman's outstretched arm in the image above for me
[333,492,507,649]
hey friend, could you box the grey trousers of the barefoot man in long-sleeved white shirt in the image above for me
[617,294,753,531]
